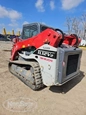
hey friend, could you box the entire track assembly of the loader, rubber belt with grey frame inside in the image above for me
[9,60,43,90]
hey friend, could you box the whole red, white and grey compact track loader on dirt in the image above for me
[8,23,82,90]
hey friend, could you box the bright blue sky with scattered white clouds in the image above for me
[0,0,86,33]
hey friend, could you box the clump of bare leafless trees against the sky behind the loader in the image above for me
[65,13,86,40]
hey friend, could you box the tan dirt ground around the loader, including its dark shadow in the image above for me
[0,41,86,115]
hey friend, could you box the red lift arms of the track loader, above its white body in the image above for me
[11,29,80,60]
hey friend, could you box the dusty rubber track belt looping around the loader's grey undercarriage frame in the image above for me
[9,60,43,90]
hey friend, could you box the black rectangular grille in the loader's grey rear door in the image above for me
[66,54,79,76]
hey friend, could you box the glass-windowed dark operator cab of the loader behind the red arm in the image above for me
[21,23,53,39]
